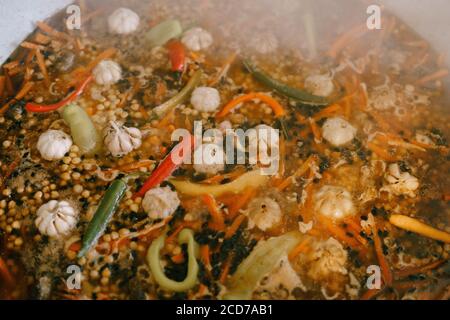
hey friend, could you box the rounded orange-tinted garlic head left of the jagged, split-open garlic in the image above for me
[314,186,356,220]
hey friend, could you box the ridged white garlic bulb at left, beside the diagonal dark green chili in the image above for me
[35,200,78,238]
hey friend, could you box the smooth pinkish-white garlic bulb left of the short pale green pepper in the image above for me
[37,130,72,161]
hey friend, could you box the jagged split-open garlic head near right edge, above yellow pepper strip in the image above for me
[381,163,419,198]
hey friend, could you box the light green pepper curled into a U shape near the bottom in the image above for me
[147,229,199,292]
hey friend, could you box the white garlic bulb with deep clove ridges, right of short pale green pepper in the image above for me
[103,121,142,157]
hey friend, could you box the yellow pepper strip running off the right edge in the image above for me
[389,214,450,243]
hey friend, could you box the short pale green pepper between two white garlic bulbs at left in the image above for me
[62,103,102,156]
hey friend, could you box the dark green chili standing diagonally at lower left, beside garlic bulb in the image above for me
[78,179,127,258]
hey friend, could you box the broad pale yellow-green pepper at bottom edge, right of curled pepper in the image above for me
[223,231,302,300]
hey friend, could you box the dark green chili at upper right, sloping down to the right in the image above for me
[244,61,331,106]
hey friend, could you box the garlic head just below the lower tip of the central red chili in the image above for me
[142,187,180,219]
